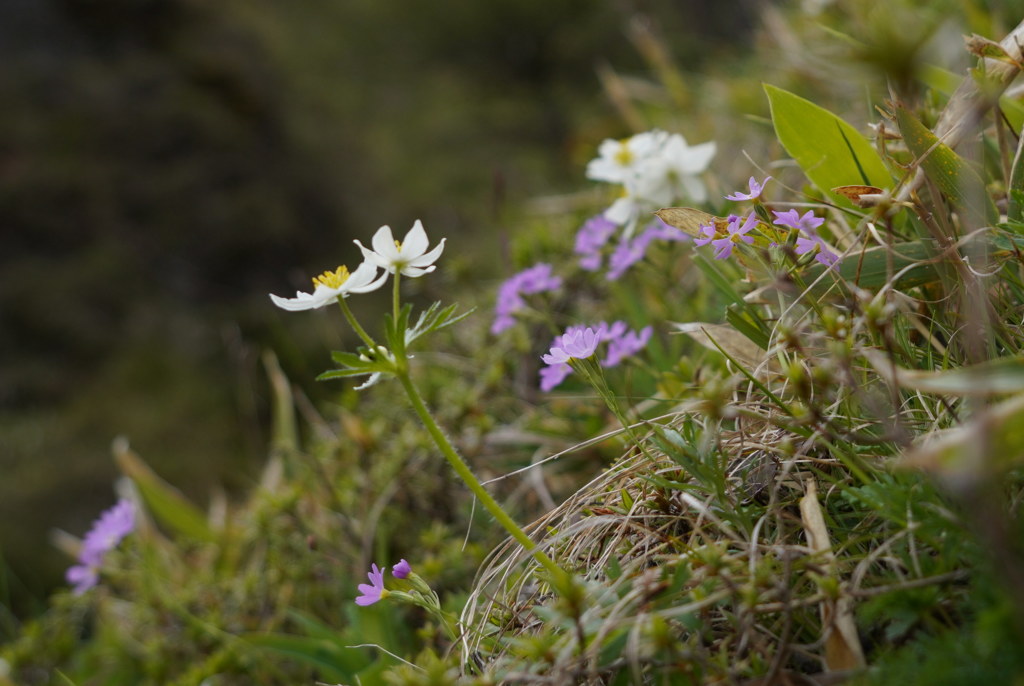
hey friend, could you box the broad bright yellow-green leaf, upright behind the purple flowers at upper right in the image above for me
[764,84,892,202]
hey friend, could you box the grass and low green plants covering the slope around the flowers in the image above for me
[6,2,1024,686]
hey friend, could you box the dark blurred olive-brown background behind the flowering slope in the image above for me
[0,0,755,614]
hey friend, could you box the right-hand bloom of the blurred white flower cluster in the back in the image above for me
[639,133,716,205]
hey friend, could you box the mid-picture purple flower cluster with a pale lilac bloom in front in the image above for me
[541,321,653,392]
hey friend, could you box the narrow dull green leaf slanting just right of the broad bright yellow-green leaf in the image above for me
[896,105,999,227]
